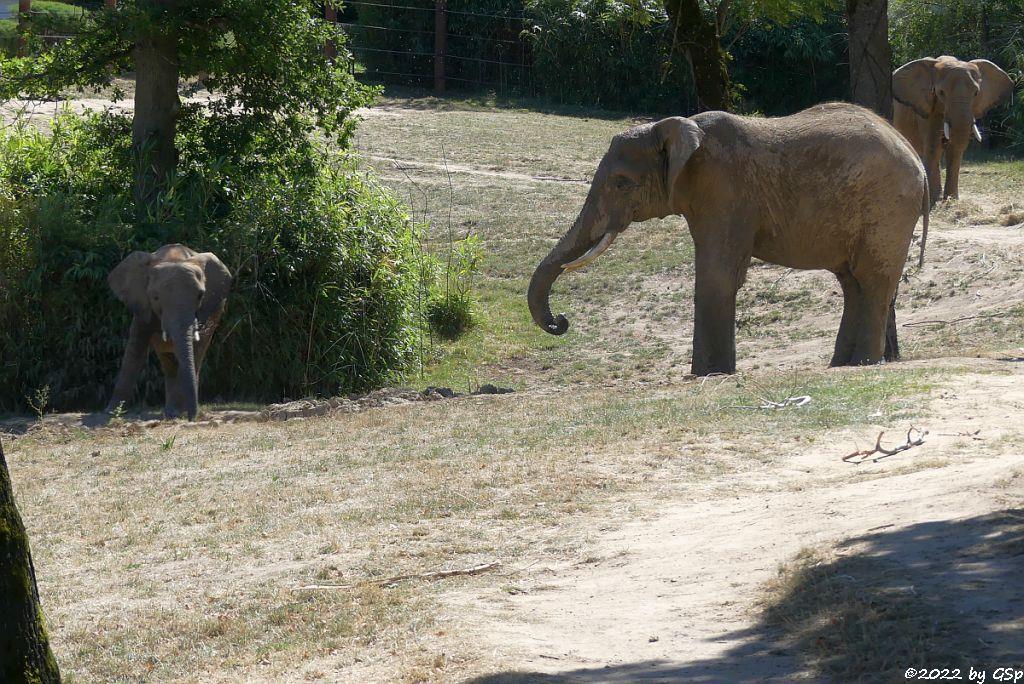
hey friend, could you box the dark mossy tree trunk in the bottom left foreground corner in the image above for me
[0,443,60,684]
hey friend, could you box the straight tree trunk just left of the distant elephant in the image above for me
[846,0,893,121]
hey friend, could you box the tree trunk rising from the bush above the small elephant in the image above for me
[132,0,181,217]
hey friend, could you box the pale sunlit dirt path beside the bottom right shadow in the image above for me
[464,361,1024,682]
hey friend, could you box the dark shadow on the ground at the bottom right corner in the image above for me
[469,509,1024,684]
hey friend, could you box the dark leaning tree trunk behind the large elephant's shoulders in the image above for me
[665,0,732,112]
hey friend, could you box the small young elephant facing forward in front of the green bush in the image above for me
[106,245,231,421]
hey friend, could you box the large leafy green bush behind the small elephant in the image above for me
[0,114,424,411]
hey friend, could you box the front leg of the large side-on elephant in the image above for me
[690,249,749,376]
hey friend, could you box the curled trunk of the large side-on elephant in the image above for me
[526,202,617,335]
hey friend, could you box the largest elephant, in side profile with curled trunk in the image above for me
[527,103,928,375]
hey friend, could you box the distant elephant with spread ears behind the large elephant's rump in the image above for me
[893,56,1014,203]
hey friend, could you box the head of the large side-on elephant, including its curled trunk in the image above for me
[527,117,703,335]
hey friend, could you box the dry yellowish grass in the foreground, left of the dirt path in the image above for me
[9,362,932,681]
